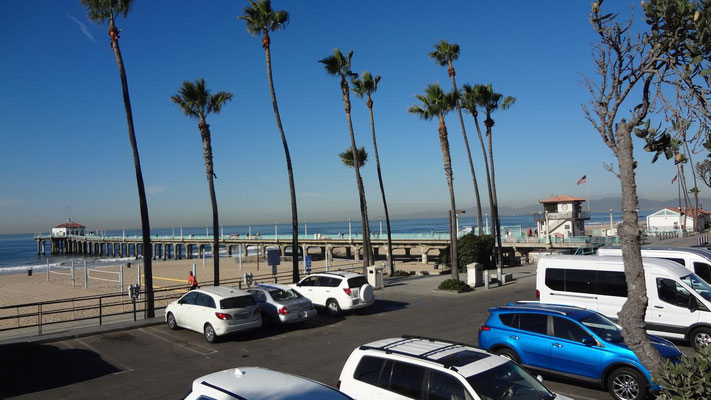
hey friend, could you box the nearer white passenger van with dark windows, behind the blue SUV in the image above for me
[536,256,711,349]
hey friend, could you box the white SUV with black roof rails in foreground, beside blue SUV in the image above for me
[338,336,571,400]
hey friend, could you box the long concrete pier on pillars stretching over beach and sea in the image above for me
[35,233,617,265]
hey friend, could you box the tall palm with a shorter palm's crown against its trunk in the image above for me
[319,48,372,274]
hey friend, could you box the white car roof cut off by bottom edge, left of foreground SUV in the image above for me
[184,367,352,400]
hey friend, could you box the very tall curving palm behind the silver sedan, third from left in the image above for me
[239,0,299,282]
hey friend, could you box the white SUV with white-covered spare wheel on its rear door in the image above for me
[294,272,375,315]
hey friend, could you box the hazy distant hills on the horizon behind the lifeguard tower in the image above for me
[393,197,711,219]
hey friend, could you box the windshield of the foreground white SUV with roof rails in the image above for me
[467,361,555,400]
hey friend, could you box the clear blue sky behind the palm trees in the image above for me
[0,0,688,233]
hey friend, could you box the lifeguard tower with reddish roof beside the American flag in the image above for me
[535,195,590,238]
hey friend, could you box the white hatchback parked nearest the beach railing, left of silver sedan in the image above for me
[165,286,262,343]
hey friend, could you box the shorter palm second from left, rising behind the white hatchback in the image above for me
[170,78,232,286]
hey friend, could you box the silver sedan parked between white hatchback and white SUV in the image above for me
[247,284,316,324]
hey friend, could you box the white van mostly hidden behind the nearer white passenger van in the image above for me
[597,246,711,284]
